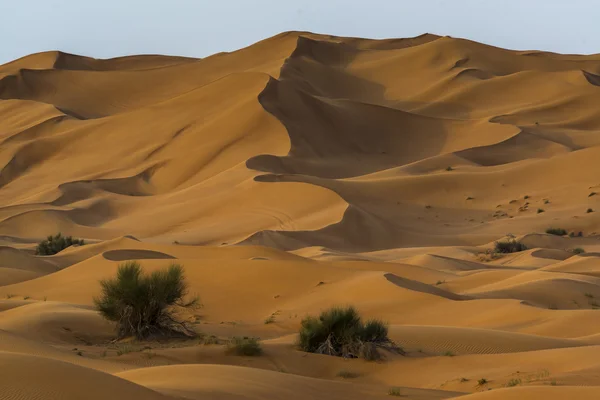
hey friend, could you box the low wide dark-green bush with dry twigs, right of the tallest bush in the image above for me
[298,307,401,360]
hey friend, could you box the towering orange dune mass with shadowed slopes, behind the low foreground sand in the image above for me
[0,33,600,251]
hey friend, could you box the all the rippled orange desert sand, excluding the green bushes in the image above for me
[0,32,600,400]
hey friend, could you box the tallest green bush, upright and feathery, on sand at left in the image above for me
[94,261,198,339]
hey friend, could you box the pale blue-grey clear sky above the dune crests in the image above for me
[0,0,600,63]
